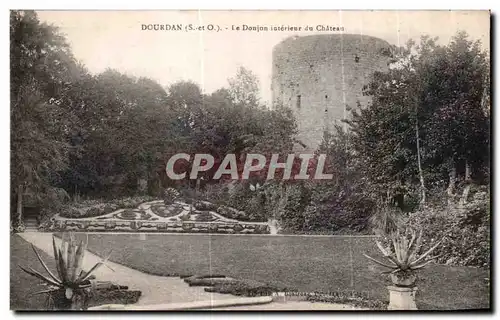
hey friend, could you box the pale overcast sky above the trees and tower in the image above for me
[38,11,490,101]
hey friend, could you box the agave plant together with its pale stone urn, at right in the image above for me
[363,230,442,310]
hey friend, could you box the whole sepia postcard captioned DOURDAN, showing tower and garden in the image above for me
[10,10,492,312]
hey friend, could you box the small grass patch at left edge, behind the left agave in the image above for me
[10,235,56,310]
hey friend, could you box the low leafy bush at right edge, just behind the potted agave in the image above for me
[408,192,490,267]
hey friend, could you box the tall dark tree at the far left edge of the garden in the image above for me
[10,11,80,225]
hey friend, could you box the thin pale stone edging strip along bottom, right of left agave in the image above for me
[88,297,273,311]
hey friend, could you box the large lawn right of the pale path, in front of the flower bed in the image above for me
[84,234,490,310]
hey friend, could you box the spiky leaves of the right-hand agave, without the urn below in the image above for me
[363,230,442,287]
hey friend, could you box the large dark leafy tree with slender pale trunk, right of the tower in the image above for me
[349,32,489,208]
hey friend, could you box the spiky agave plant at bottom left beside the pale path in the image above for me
[19,233,111,310]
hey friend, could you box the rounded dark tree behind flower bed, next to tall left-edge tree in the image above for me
[61,70,178,195]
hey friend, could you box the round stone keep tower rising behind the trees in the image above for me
[271,34,390,151]
